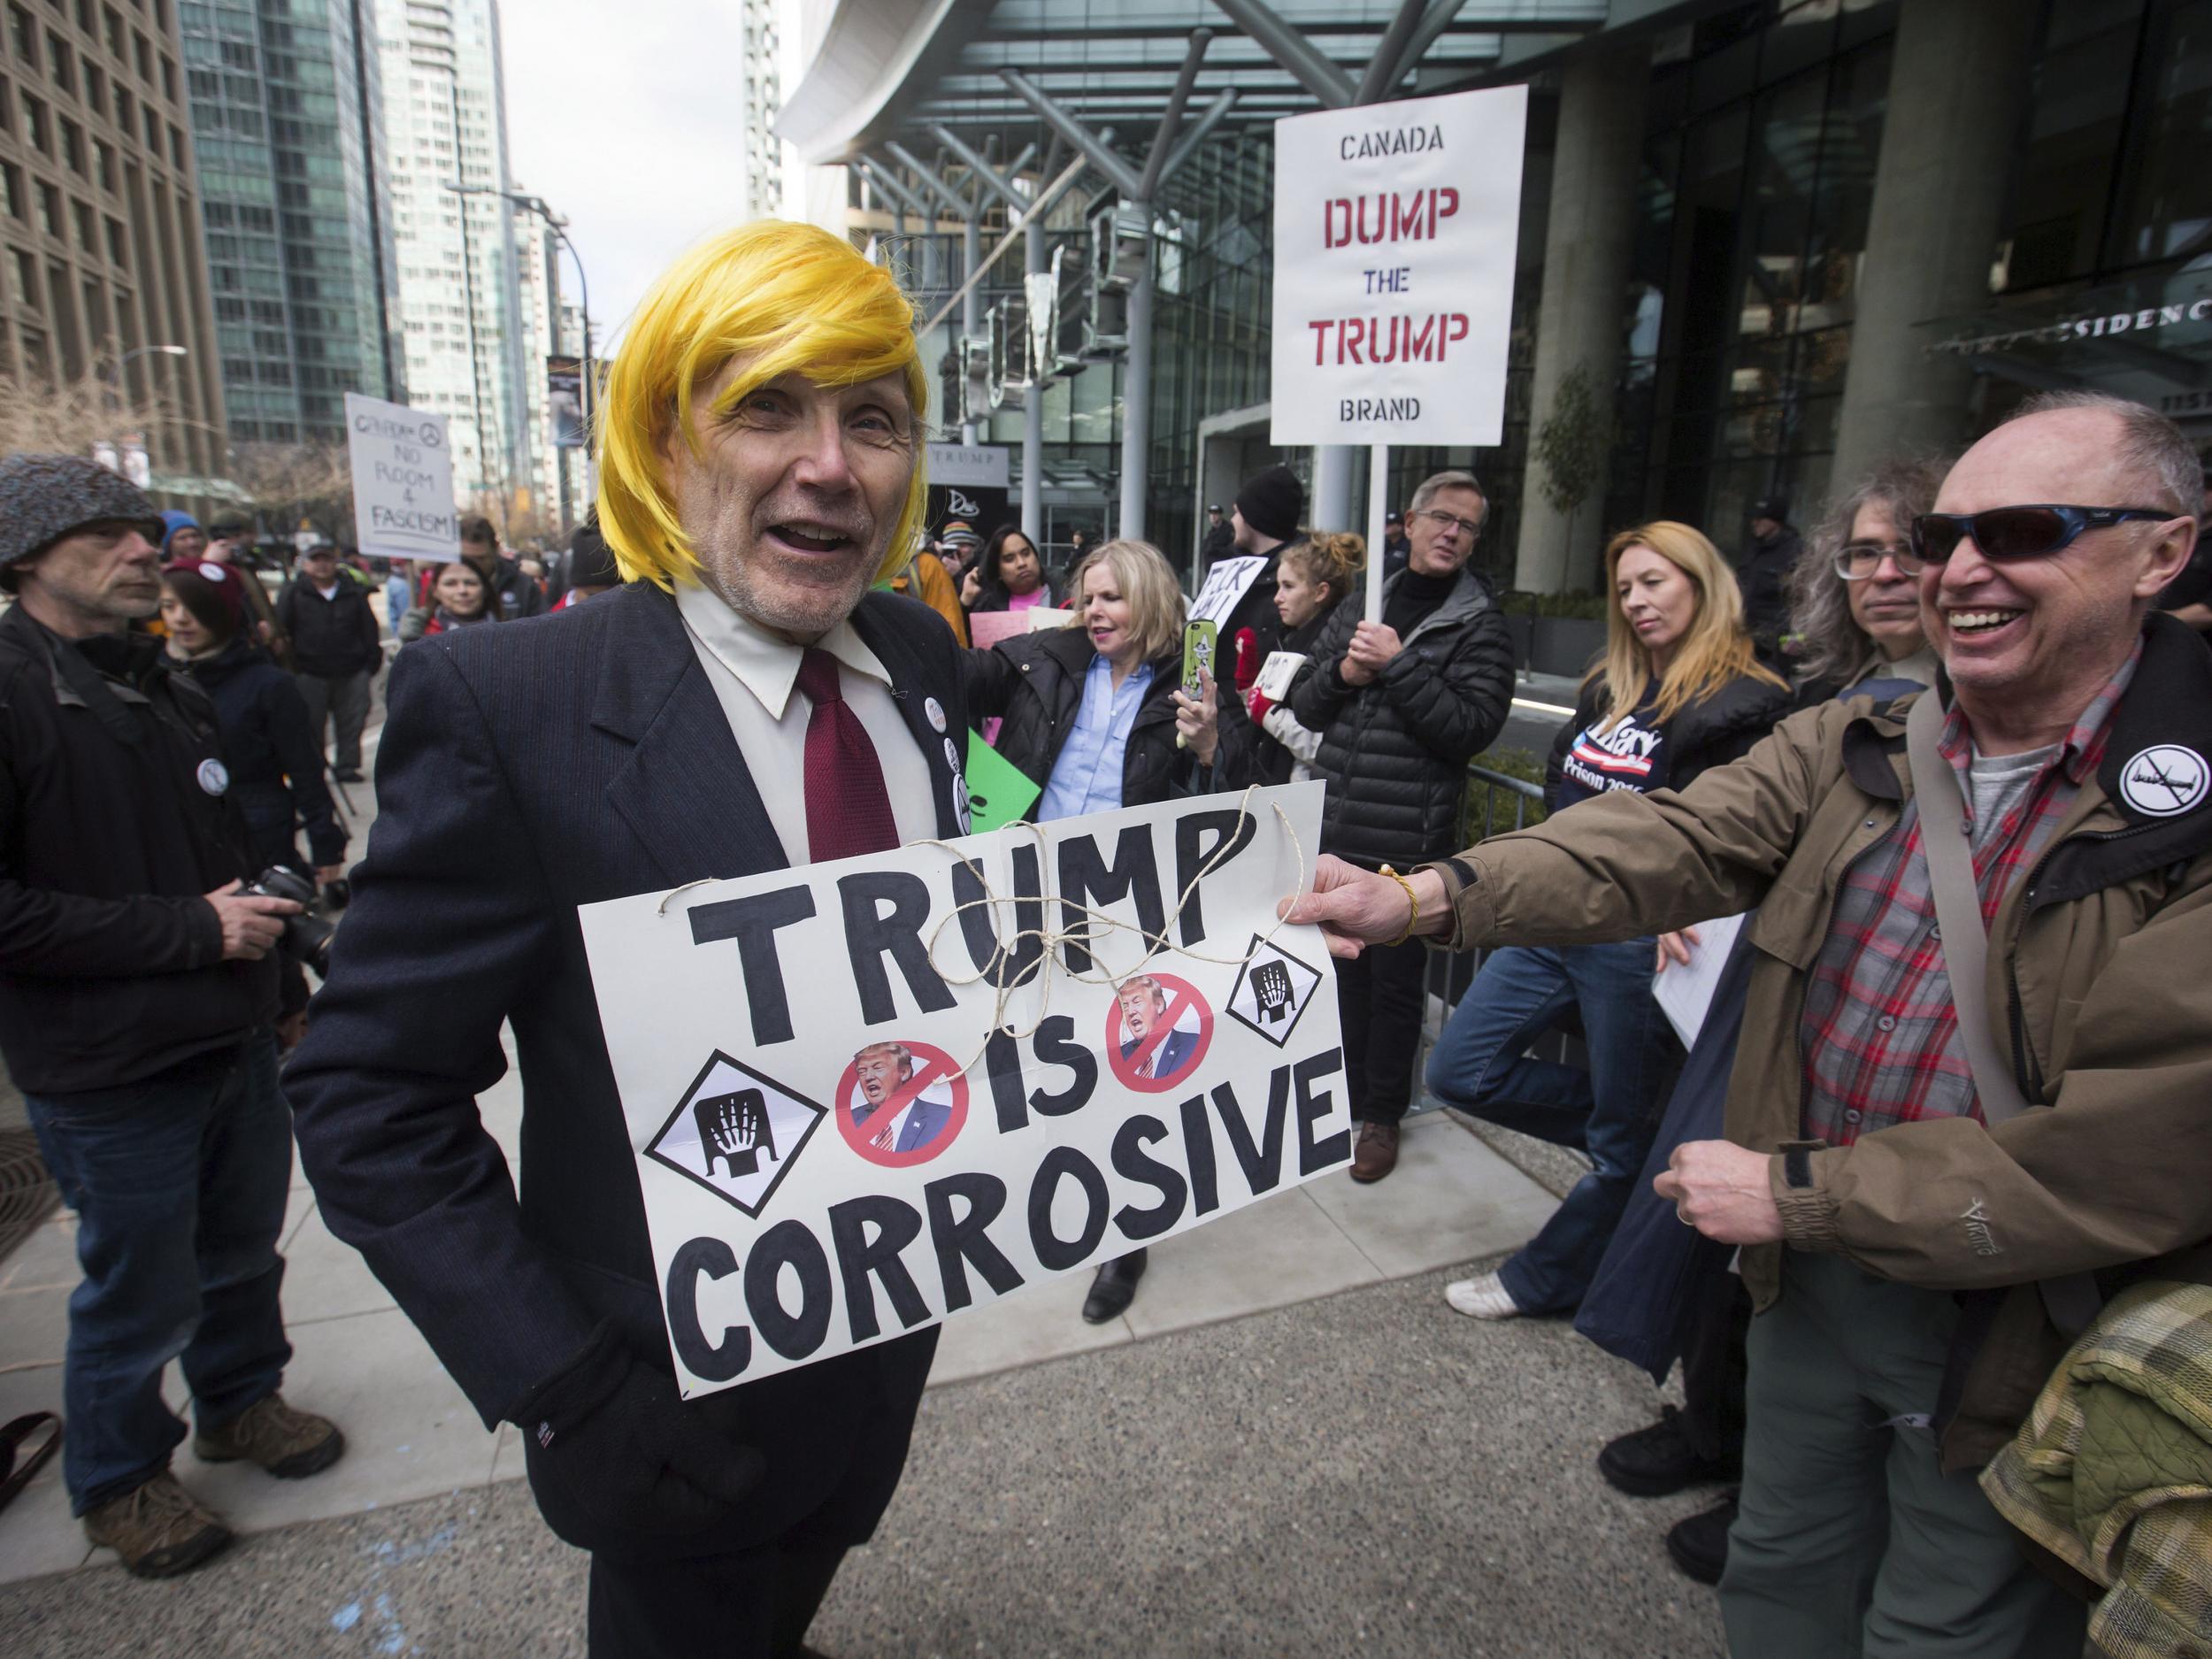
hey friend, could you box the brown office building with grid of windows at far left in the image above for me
[0,0,228,487]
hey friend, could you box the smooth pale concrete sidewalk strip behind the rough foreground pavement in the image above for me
[0,1097,1553,1584]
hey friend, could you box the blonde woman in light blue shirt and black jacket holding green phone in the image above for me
[967,542,1217,1325]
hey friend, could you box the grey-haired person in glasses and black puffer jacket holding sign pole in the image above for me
[1283,473,1513,1181]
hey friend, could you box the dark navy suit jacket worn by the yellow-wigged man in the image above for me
[286,584,967,1548]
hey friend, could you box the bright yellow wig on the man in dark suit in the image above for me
[595,219,929,588]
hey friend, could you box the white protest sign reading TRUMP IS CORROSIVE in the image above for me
[580,783,1352,1396]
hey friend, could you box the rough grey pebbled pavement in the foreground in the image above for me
[0,1265,1721,1659]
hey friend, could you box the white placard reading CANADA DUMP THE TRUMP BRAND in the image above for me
[1270,87,1529,445]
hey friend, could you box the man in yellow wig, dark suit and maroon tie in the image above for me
[286,224,967,1659]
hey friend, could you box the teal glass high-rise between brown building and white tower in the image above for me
[177,0,405,442]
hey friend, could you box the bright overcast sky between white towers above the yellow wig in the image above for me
[500,0,770,352]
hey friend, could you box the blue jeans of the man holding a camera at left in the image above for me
[25,1031,292,1516]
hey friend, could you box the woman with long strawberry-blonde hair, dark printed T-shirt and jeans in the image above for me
[1429,520,1790,1318]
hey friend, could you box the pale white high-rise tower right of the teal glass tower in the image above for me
[376,0,526,522]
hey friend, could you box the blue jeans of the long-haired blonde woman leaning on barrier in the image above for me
[1429,938,1668,1314]
